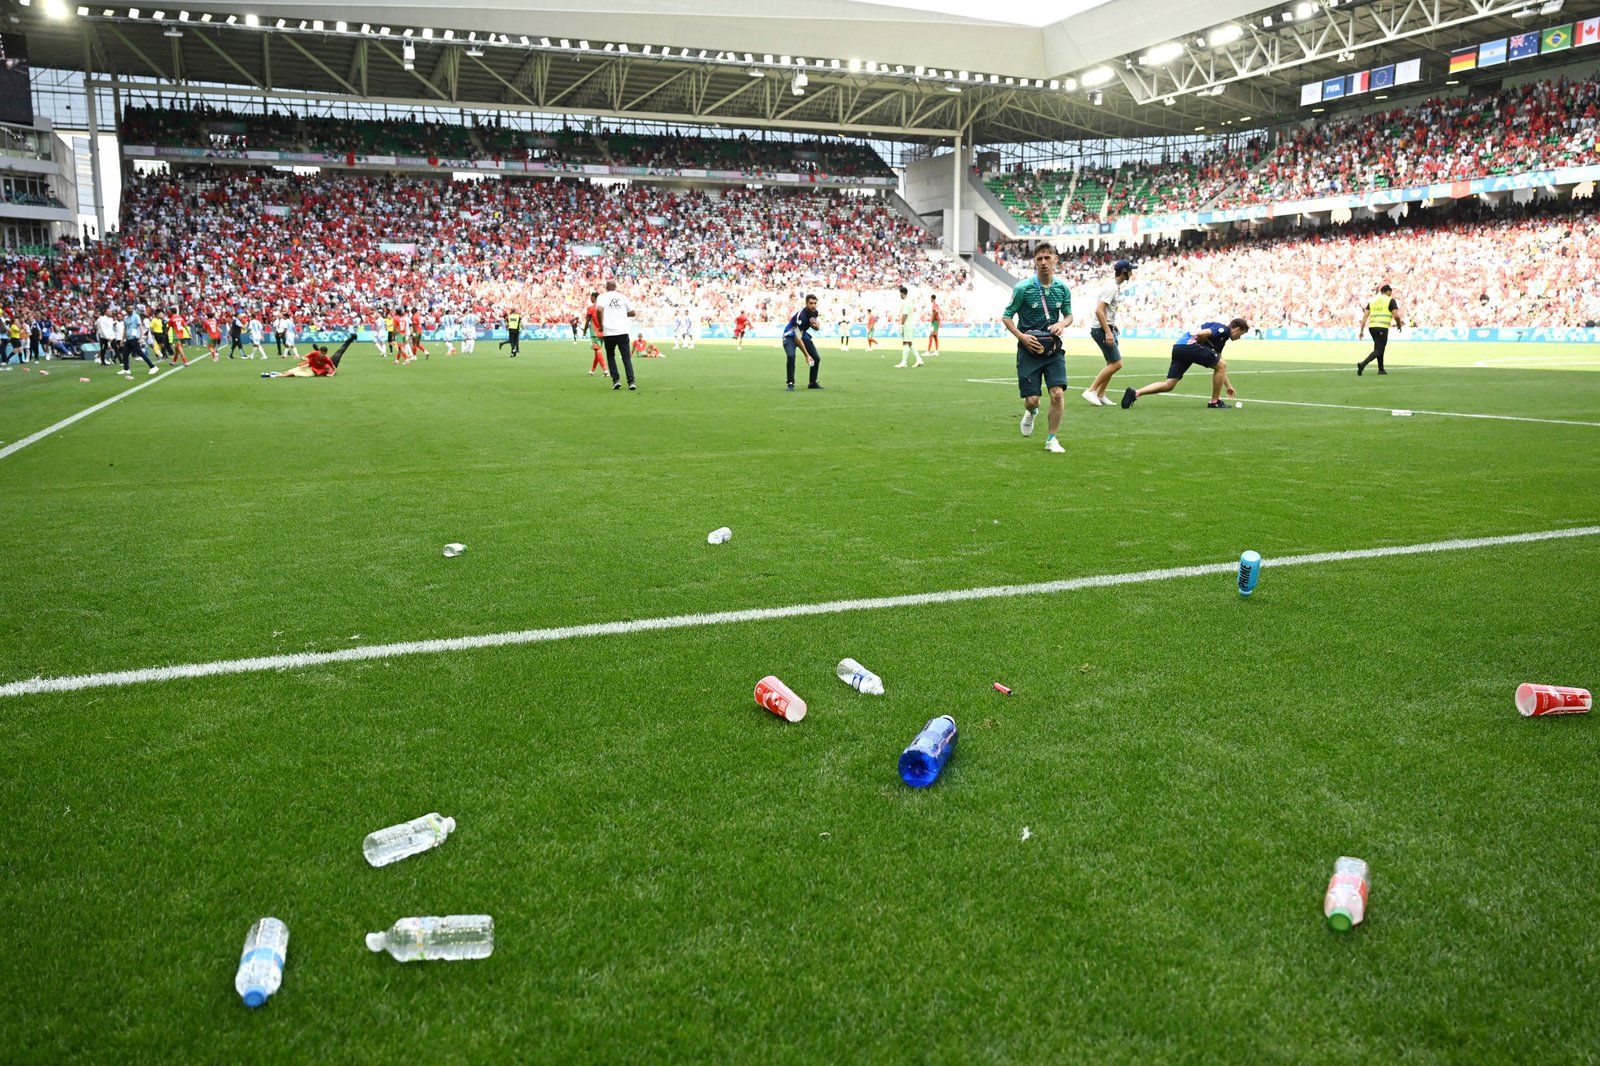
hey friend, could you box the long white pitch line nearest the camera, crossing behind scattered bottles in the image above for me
[0,525,1600,698]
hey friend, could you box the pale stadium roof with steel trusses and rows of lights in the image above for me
[22,0,1600,144]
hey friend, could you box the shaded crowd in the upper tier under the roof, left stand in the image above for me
[122,104,893,178]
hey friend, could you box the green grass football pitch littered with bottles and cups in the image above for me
[0,341,1600,1063]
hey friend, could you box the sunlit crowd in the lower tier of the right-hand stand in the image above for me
[992,200,1600,328]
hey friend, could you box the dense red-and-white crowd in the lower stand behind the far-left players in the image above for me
[0,166,970,337]
